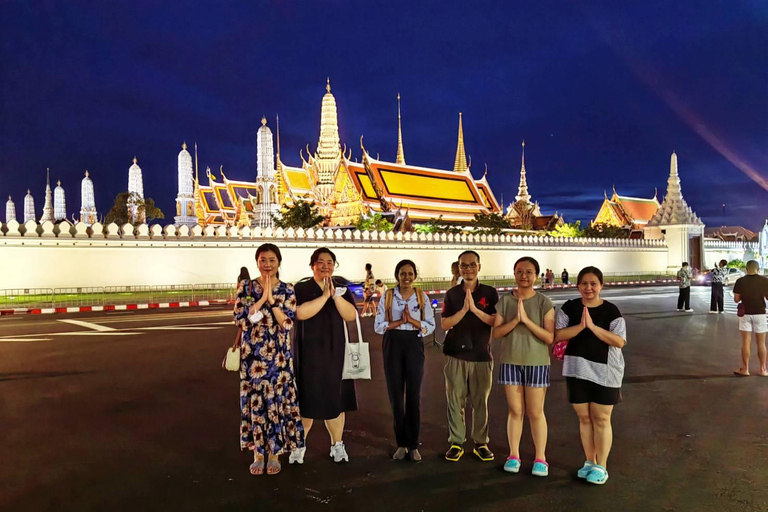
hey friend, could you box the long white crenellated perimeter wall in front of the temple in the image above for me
[0,223,668,289]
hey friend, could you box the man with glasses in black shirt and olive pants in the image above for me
[440,251,499,462]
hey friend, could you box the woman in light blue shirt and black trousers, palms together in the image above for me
[374,260,435,462]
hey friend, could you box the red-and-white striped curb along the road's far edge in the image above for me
[0,279,677,316]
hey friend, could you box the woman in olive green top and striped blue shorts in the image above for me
[492,256,555,476]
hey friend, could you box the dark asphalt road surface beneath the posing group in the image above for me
[0,287,768,512]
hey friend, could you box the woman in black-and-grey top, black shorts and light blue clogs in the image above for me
[555,267,627,484]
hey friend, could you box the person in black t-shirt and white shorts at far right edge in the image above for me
[733,260,768,377]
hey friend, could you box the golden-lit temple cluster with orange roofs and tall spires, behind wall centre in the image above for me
[195,81,501,226]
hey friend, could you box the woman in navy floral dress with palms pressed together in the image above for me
[234,244,304,475]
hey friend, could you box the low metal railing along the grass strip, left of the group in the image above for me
[0,283,235,309]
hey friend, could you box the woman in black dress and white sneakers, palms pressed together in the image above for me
[289,247,357,464]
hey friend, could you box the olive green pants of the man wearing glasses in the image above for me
[443,356,493,445]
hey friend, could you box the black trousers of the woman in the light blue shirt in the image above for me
[382,329,424,450]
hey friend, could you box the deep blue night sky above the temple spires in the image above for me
[0,0,768,229]
